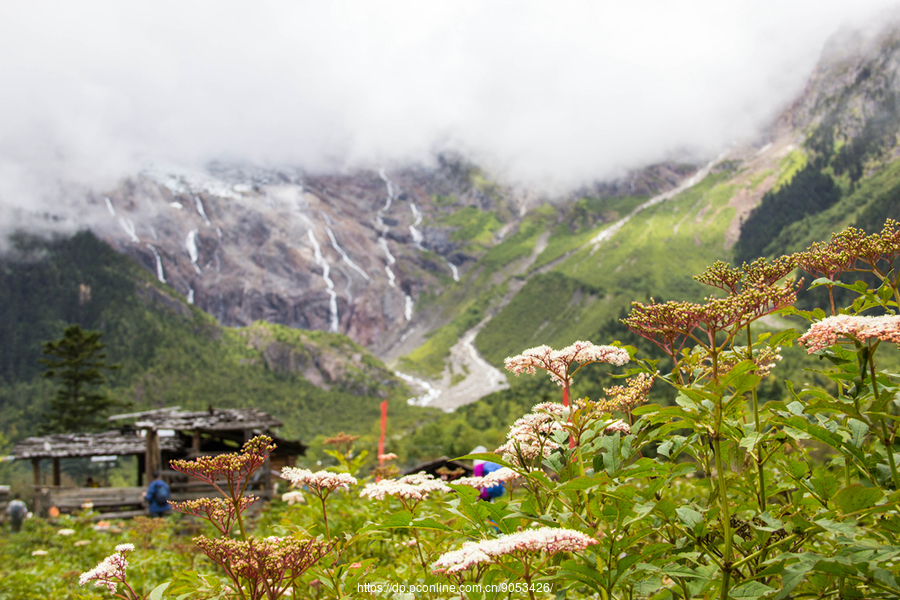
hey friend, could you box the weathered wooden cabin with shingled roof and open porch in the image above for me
[13,407,306,518]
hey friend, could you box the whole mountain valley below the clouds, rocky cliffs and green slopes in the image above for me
[0,21,900,462]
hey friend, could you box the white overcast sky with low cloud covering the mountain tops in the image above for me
[0,0,892,206]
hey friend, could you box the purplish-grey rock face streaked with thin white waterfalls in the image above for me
[90,157,687,353]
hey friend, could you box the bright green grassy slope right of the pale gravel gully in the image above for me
[476,172,734,364]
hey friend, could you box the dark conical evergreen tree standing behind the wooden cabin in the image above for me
[41,325,123,433]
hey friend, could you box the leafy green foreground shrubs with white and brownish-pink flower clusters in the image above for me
[10,221,900,600]
